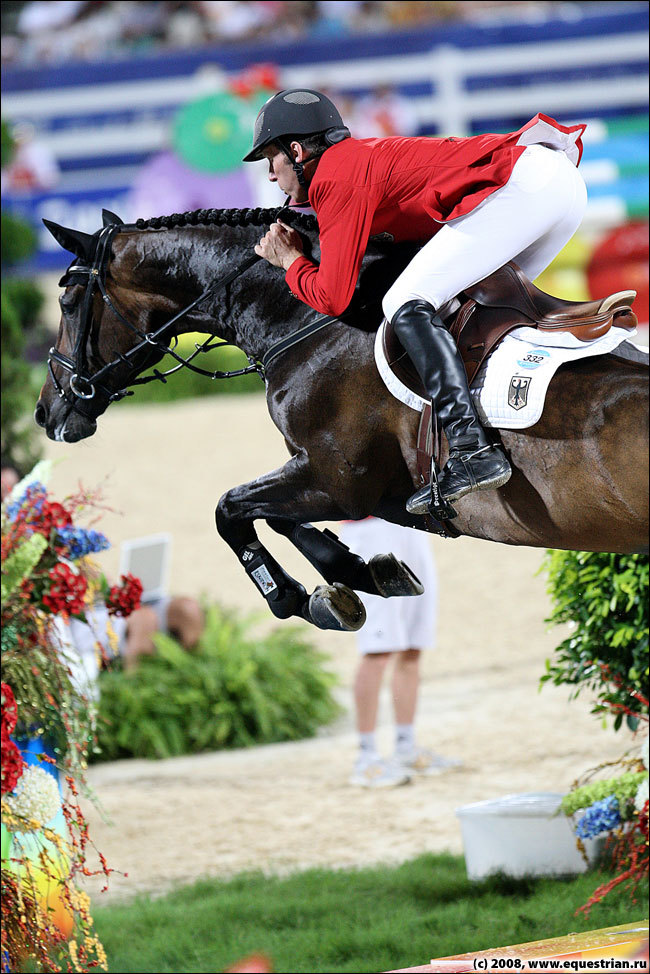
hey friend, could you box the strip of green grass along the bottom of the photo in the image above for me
[93,856,646,974]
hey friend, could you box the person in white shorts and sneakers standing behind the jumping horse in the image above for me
[341,517,459,788]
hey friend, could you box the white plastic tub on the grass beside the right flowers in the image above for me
[456,792,602,879]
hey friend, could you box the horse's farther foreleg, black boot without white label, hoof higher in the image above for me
[268,518,424,598]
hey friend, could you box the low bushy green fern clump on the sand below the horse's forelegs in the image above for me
[98,606,339,761]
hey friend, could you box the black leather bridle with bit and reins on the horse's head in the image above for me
[47,221,272,419]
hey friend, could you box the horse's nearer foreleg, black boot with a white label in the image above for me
[215,456,365,630]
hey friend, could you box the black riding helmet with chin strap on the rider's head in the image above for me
[243,88,350,185]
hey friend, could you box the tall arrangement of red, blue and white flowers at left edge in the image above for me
[1,463,142,971]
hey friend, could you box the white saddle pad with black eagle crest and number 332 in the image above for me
[375,322,636,429]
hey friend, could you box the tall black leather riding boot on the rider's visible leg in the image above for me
[392,300,511,514]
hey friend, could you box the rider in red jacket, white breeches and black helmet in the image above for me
[244,88,586,514]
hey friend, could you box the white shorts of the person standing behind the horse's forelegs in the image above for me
[341,518,438,655]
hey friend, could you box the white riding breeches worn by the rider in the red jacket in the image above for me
[383,145,587,321]
